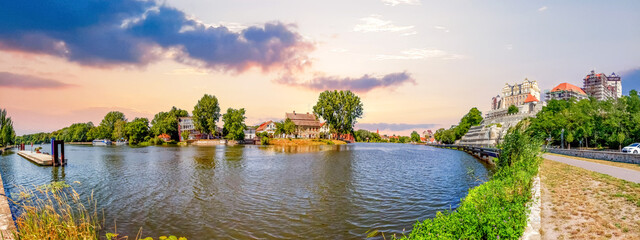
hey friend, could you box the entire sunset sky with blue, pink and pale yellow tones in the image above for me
[0,0,640,135]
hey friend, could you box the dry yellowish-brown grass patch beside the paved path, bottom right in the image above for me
[540,160,640,239]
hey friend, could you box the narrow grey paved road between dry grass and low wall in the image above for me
[542,154,640,183]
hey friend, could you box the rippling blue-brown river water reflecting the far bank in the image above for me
[0,143,490,239]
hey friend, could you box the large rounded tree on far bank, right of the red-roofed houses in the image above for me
[313,90,363,134]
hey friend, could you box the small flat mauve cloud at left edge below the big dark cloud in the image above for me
[0,72,73,90]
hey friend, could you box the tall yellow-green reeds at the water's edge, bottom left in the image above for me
[13,181,186,240]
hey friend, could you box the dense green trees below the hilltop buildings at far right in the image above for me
[528,90,640,149]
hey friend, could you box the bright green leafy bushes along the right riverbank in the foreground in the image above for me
[402,122,540,239]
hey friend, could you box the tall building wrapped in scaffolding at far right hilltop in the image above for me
[583,70,622,100]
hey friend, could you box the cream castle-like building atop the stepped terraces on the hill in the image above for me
[500,78,540,110]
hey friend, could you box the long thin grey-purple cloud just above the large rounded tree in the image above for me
[275,72,417,93]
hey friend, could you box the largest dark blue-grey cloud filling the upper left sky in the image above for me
[0,0,314,72]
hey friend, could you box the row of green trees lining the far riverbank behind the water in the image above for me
[17,91,363,144]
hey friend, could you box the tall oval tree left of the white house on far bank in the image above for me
[192,94,220,138]
